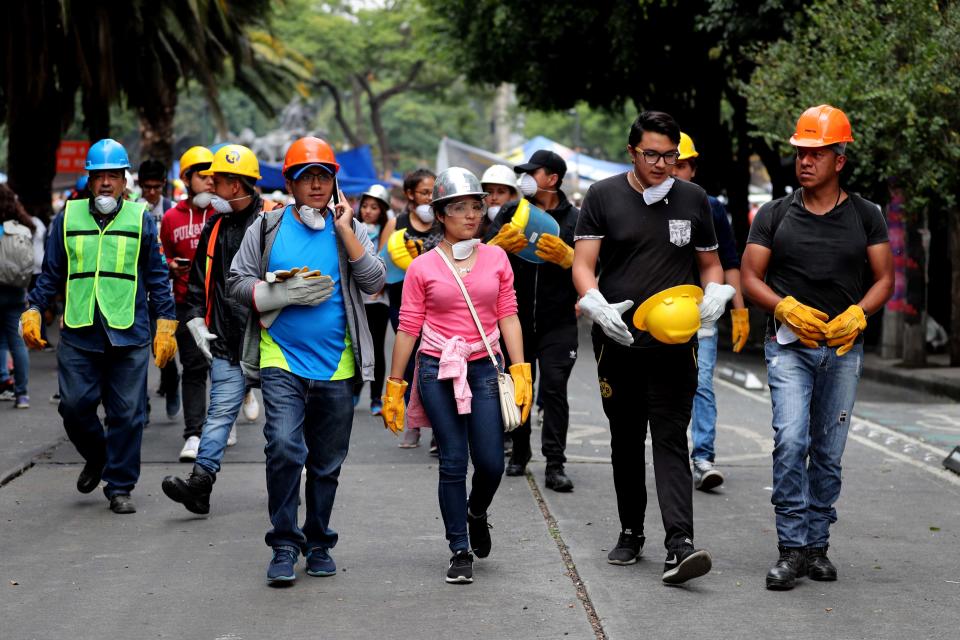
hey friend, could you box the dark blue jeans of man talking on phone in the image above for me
[260,367,353,553]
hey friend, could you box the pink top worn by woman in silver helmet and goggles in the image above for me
[399,244,517,360]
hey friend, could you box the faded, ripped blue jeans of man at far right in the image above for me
[764,339,863,548]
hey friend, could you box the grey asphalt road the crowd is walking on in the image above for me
[0,322,960,640]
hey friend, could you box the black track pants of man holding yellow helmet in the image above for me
[593,337,697,549]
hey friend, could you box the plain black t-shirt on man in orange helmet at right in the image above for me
[747,190,888,330]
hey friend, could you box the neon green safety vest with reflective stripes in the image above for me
[63,200,146,329]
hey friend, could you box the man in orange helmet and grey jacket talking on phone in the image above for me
[229,137,385,585]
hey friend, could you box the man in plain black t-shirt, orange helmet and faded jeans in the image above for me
[742,105,893,590]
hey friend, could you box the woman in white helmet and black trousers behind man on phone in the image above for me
[353,184,390,416]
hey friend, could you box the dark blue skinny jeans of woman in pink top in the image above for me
[417,354,503,552]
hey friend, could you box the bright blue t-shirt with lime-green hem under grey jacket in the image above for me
[260,206,355,380]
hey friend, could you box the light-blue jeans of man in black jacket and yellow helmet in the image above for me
[194,360,246,474]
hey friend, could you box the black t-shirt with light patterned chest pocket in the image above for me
[576,173,717,348]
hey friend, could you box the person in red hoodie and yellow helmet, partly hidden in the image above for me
[160,147,213,462]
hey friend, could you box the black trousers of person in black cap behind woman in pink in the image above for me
[510,324,577,468]
